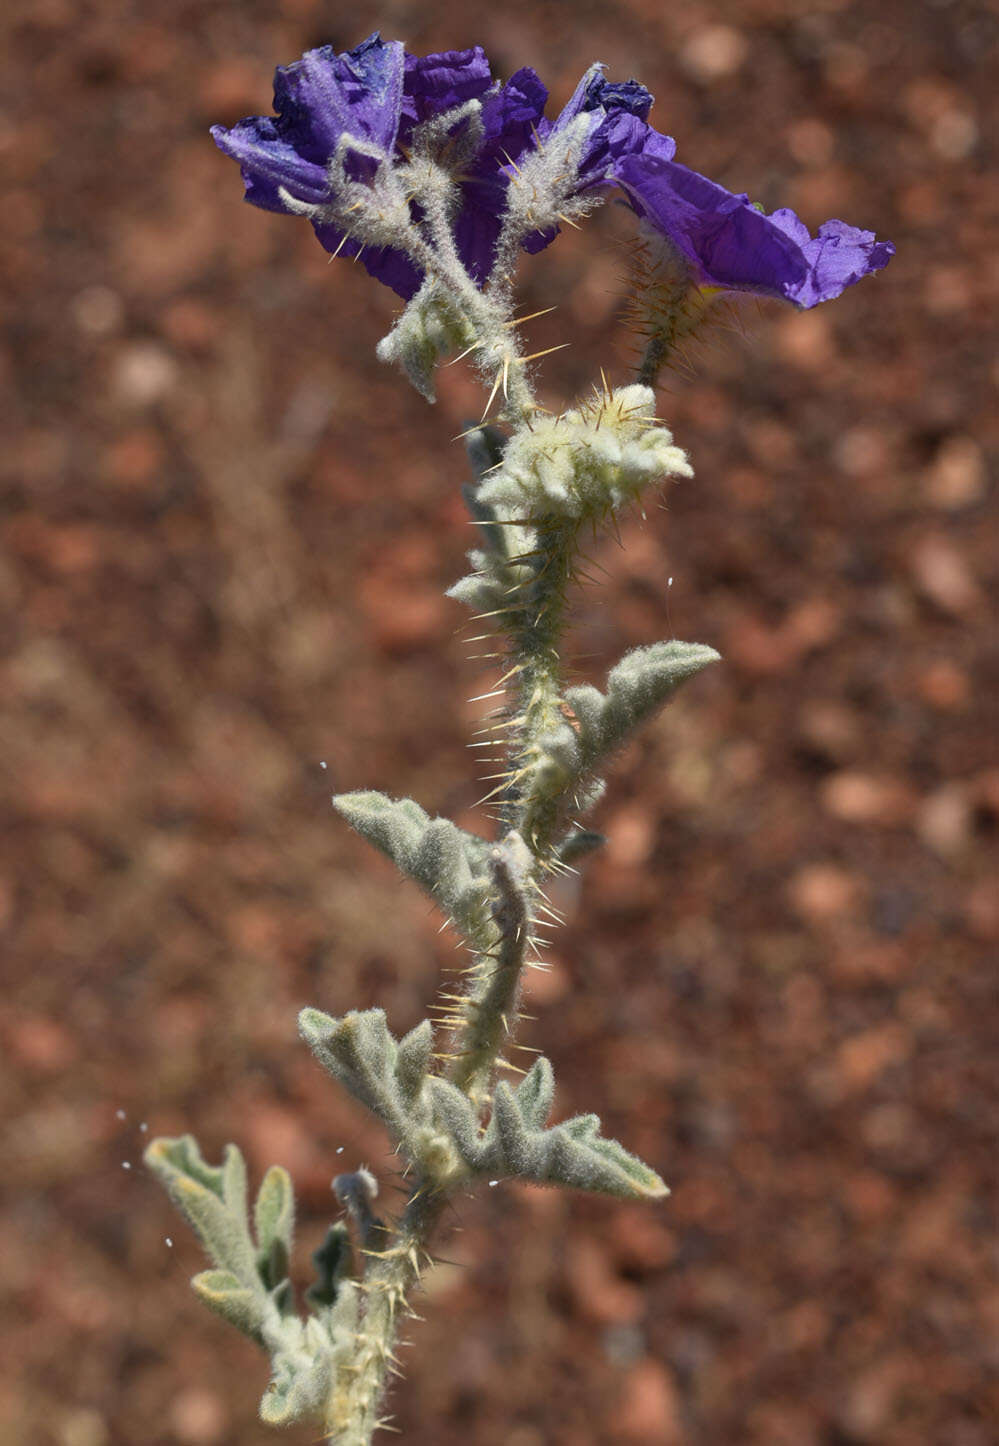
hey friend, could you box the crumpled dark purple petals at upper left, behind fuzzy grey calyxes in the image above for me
[213,33,672,299]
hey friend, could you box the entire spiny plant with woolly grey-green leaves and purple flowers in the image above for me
[146,25,892,1446]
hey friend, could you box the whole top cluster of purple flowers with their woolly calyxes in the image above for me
[213,33,895,307]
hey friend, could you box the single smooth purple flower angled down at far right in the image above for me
[614,150,895,308]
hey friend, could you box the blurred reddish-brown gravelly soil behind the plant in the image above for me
[0,0,999,1446]
